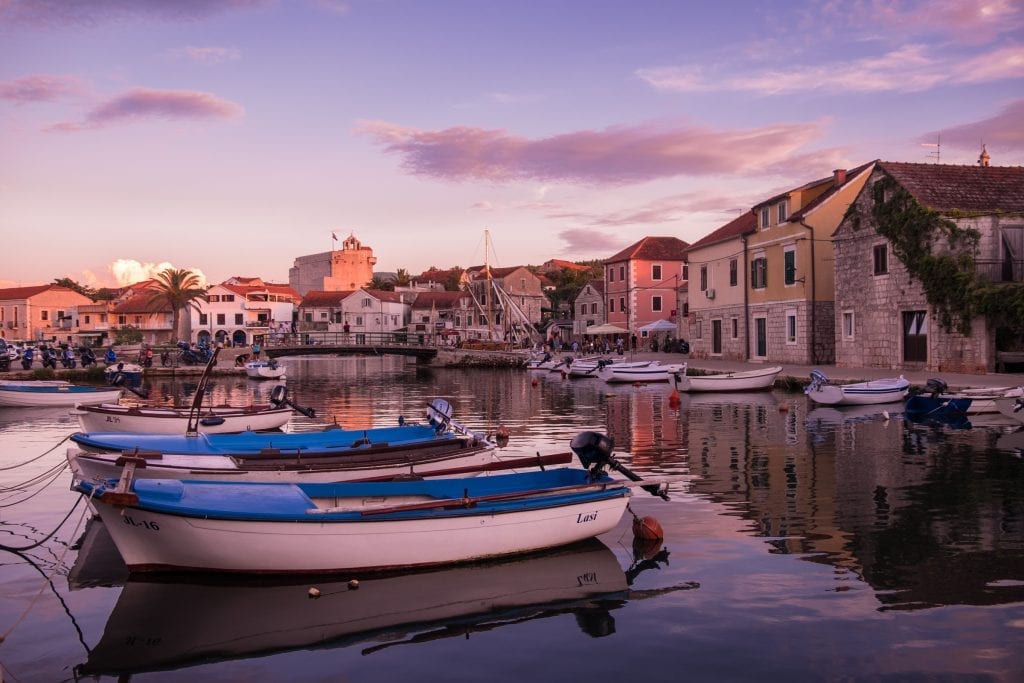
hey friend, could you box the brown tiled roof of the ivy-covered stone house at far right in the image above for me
[879,161,1024,213]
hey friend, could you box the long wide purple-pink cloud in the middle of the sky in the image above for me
[358,121,821,184]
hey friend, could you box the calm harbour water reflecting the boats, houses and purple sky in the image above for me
[0,357,1024,683]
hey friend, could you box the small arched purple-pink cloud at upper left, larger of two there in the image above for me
[51,88,245,131]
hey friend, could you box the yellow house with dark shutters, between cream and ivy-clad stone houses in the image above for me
[745,164,871,365]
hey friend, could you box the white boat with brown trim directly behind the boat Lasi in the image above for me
[67,438,572,483]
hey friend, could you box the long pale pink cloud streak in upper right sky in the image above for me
[636,45,1024,95]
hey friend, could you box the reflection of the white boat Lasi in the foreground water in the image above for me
[78,540,629,676]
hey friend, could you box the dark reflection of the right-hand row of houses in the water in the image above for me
[686,394,1024,609]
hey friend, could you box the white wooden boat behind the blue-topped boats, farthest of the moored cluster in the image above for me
[75,403,292,434]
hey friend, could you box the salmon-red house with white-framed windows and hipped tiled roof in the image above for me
[604,237,689,338]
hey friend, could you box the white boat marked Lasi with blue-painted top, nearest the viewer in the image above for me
[86,470,629,573]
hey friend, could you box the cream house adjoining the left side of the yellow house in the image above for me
[686,211,757,360]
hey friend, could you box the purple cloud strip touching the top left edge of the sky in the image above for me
[0,0,269,27]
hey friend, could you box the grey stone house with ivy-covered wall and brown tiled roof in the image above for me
[835,158,1024,373]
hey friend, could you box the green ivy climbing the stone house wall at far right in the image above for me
[871,176,1024,336]
